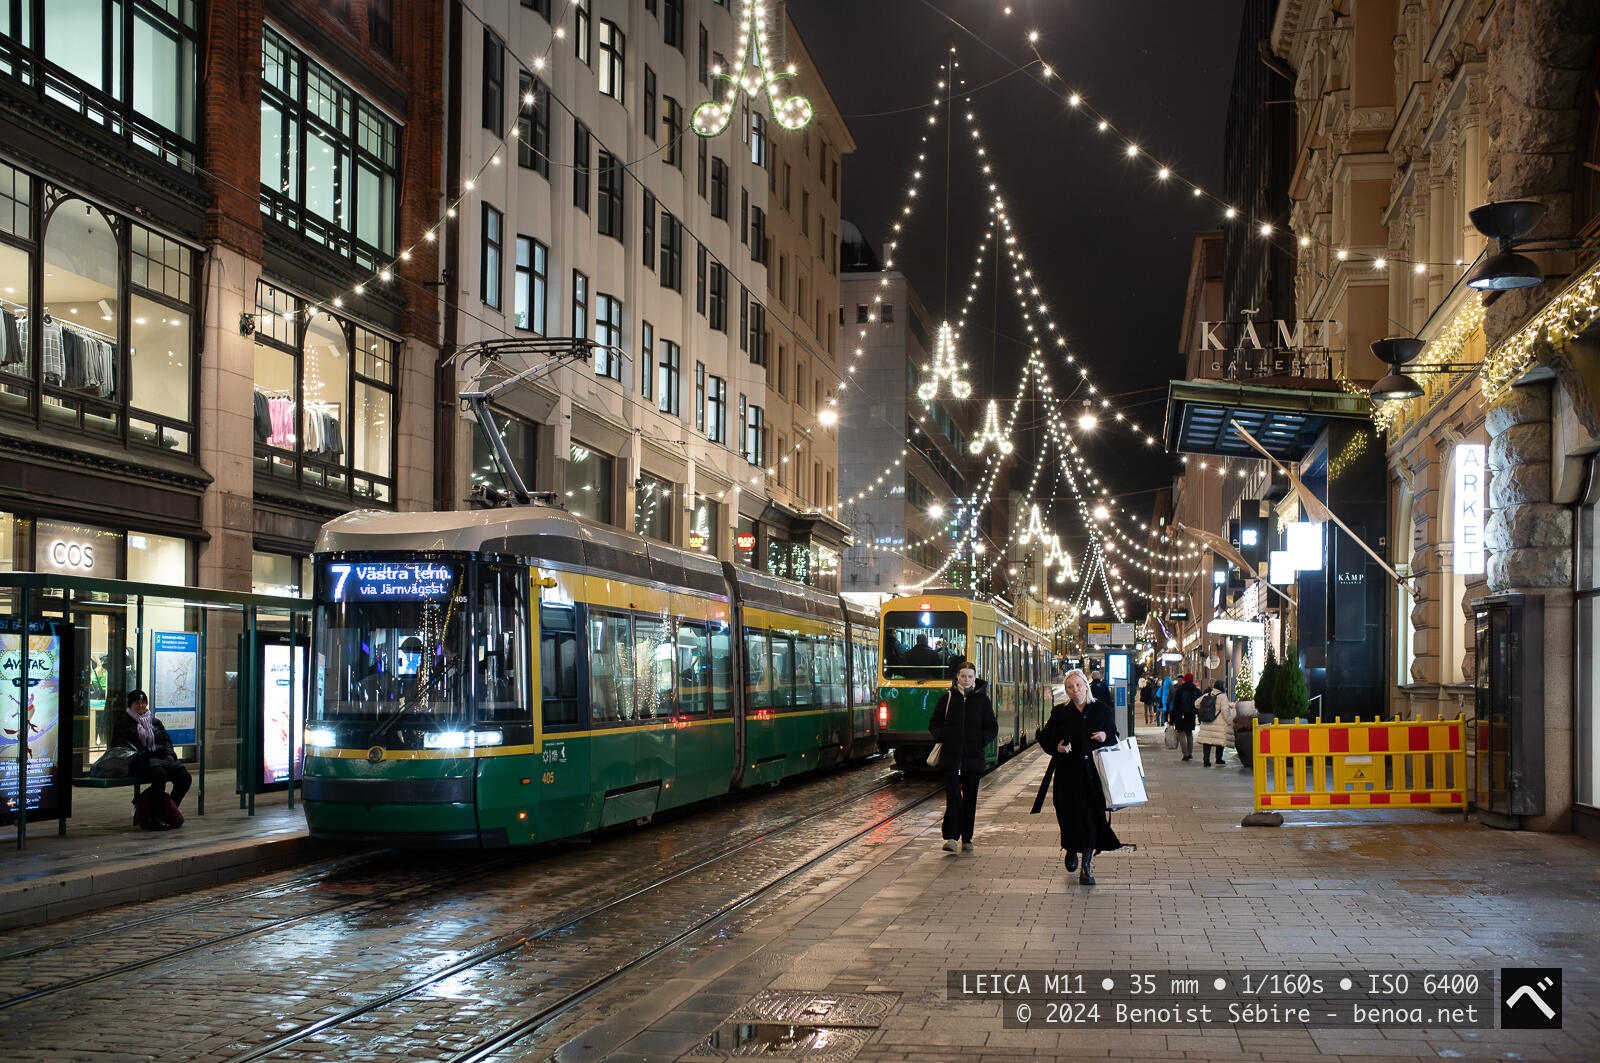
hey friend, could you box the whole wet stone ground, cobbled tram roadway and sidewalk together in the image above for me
[0,751,1600,1063]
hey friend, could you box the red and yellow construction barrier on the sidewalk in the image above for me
[1251,716,1467,812]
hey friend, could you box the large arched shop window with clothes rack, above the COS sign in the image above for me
[0,175,198,457]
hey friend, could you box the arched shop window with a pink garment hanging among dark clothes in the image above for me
[254,282,397,503]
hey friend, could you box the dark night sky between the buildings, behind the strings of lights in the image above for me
[789,0,1243,538]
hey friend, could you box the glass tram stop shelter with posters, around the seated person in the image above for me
[0,573,310,848]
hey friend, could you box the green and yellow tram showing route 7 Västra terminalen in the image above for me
[304,506,878,847]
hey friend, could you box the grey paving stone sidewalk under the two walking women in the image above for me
[560,740,1600,1063]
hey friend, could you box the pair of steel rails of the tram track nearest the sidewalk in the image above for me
[226,773,944,1063]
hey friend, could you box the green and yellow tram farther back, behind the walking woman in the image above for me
[878,592,1050,768]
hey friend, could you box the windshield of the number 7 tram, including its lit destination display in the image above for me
[310,560,470,743]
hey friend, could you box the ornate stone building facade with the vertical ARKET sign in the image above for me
[1272,0,1600,831]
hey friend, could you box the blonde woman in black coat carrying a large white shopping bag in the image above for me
[1038,669,1122,885]
